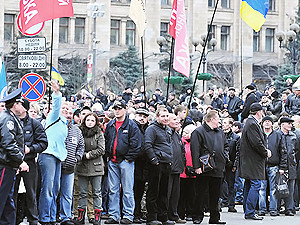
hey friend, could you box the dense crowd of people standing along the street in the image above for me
[0,79,300,225]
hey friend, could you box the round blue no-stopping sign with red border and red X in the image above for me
[19,73,46,101]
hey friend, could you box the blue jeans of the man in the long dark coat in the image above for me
[243,179,261,217]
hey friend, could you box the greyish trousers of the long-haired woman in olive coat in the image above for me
[78,175,102,210]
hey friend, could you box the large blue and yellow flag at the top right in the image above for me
[241,0,269,32]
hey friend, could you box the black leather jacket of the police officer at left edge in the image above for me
[0,109,25,169]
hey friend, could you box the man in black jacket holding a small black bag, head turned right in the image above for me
[191,110,229,224]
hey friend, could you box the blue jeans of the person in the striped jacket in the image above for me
[59,173,74,222]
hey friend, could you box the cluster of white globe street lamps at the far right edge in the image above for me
[275,23,300,75]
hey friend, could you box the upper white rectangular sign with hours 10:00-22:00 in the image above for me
[17,37,46,53]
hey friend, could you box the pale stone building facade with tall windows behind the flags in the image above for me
[0,0,298,94]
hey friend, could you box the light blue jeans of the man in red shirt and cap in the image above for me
[108,160,135,221]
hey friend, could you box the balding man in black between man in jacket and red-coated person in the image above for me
[168,114,186,223]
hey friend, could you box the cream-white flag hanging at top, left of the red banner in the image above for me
[129,0,147,37]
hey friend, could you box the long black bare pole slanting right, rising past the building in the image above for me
[181,0,219,135]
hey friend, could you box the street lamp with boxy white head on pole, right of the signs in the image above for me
[87,0,105,94]
